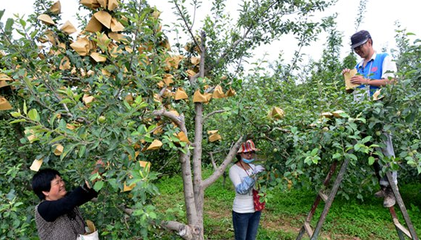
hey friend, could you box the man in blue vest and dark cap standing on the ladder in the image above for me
[342,30,397,207]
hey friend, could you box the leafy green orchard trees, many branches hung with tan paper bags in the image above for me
[0,0,421,239]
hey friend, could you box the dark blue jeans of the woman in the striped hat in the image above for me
[232,211,262,240]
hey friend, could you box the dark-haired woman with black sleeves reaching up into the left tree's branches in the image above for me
[32,168,98,240]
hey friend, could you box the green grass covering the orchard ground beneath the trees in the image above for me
[155,169,421,240]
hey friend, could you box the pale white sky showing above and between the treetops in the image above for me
[0,0,421,65]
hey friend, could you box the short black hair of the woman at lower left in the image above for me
[32,168,61,200]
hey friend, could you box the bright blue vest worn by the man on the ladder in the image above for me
[355,53,387,96]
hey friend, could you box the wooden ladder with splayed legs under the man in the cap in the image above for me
[296,159,418,240]
